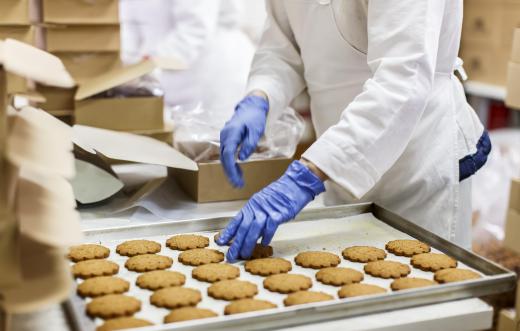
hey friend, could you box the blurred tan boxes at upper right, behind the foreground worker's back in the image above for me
[461,0,520,86]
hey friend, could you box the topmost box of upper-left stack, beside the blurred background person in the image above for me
[41,0,119,24]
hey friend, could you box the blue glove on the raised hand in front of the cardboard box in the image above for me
[220,95,269,187]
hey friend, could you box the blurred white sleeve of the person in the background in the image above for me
[152,0,220,66]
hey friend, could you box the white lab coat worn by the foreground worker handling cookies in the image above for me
[248,0,483,247]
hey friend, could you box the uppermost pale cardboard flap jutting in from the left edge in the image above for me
[0,39,75,88]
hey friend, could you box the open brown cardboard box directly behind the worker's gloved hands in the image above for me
[168,158,291,202]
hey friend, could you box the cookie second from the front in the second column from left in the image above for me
[150,287,202,309]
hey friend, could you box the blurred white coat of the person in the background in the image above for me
[120,0,254,111]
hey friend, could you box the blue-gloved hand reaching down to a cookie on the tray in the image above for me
[217,161,325,262]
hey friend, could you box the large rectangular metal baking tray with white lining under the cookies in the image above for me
[65,203,516,331]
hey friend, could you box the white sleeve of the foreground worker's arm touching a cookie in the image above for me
[303,0,449,198]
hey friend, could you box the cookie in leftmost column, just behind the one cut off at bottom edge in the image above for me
[87,294,141,319]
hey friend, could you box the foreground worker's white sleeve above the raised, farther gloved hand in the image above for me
[247,0,305,122]
